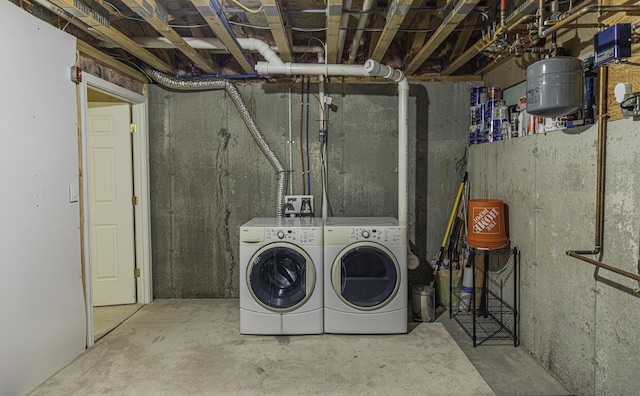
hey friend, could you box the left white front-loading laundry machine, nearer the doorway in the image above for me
[240,218,324,335]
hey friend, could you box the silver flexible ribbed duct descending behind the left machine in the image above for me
[144,65,287,217]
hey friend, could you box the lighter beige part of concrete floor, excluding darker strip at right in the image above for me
[31,299,494,396]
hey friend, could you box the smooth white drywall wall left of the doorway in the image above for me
[0,1,85,395]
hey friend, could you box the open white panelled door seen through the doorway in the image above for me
[87,103,136,306]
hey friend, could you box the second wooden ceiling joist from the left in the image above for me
[122,0,214,74]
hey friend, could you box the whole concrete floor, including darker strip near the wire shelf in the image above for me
[33,300,571,396]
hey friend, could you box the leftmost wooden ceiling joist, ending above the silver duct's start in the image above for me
[51,0,172,74]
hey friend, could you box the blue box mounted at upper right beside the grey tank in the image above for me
[593,23,631,67]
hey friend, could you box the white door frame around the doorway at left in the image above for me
[78,72,153,347]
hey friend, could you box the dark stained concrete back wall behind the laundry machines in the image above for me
[149,83,477,298]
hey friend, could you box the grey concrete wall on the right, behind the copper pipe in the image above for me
[469,119,640,395]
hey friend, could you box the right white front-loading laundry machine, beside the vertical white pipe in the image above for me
[324,217,408,334]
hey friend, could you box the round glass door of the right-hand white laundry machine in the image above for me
[331,242,400,311]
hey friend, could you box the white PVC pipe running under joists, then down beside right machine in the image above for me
[256,59,409,226]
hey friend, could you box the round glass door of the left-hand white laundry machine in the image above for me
[247,242,316,312]
